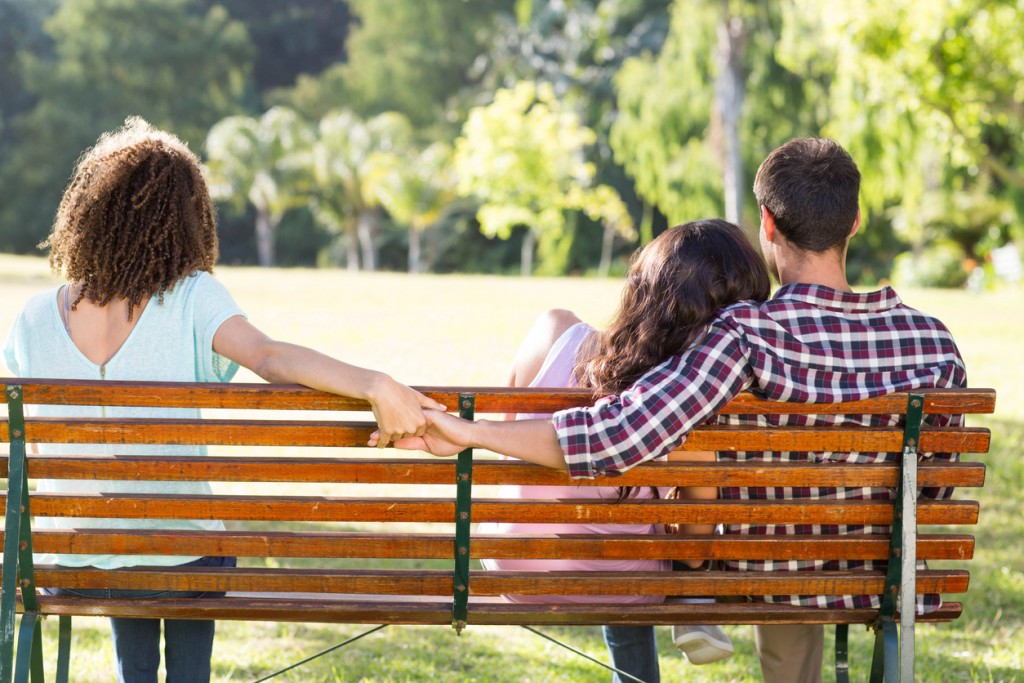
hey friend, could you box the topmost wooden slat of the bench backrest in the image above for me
[0,378,995,415]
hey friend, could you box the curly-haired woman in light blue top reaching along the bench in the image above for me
[4,118,443,683]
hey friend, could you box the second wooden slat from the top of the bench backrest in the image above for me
[12,418,989,453]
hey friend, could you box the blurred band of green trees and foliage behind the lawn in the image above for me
[0,0,1024,288]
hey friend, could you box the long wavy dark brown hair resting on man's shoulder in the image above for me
[573,219,771,498]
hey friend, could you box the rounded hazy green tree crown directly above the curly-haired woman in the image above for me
[21,0,252,150]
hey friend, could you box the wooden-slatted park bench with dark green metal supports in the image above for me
[0,379,995,683]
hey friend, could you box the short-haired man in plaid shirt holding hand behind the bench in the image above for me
[387,138,967,683]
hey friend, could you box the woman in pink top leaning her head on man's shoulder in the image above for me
[481,219,770,682]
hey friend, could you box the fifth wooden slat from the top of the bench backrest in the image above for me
[8,529,975,560]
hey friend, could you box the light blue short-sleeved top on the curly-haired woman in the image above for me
[4,272,244,569]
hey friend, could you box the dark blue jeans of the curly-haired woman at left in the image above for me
[45,557,236,683]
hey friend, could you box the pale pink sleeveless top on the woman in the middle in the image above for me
[478,323,672,603]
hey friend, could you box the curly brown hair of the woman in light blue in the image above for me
[41,117,217,319]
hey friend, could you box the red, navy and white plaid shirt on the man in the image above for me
[552,285,967,610]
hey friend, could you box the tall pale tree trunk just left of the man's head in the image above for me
[715,6,746,225]
